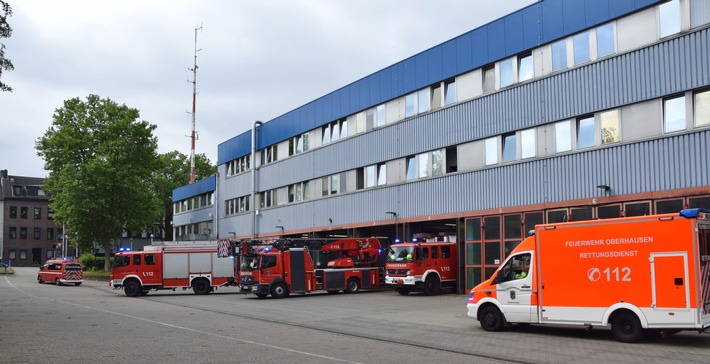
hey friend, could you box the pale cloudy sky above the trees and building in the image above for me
[0,0,536,177]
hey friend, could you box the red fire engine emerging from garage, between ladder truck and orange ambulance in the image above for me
[385,242,457,295]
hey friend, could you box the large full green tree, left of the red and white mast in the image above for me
[35,95,161,270]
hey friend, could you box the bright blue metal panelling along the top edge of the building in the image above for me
[217,0,662,165]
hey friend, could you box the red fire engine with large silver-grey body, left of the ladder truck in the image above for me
[109,245,236,297]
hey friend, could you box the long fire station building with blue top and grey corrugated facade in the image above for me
[173,0,710,292]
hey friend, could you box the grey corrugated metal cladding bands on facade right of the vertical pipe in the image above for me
[220,28,710,237]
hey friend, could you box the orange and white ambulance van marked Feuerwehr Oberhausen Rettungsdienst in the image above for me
[467,209,710,342]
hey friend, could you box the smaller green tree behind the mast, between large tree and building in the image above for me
[153,151,217,240]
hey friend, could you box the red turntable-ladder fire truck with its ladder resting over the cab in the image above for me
[220,238,383,298]
